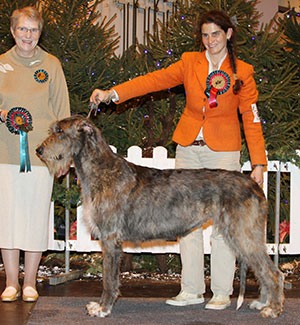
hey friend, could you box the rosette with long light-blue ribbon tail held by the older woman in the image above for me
[6,107,32,173]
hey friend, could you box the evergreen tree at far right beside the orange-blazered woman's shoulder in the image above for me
[248,19,300,166]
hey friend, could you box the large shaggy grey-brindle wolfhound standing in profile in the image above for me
[36,115,284,318]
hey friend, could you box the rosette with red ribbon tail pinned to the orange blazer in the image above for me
[205,70,230,107]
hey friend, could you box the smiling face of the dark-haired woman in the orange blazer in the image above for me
[201,23,232,60]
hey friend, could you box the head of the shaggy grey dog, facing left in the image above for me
[36,115,97,177]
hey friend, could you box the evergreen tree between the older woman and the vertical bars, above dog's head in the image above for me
[40,0,118,115]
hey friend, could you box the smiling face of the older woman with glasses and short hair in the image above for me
[10,16,41,57]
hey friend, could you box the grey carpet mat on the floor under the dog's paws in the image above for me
[28,297,300,325]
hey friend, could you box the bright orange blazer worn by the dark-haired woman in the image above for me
[113,52,267,165]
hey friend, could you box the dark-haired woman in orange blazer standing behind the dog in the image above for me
[90,10,267,310]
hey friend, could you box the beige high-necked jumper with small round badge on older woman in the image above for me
[0,46,70,166]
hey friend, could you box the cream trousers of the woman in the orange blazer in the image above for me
[175,145,241,296]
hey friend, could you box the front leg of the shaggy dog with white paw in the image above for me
[86,240,122,317]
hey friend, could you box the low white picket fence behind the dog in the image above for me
[48,146,300,255]
